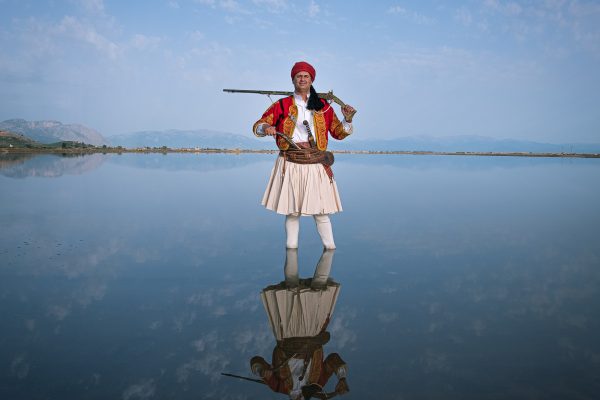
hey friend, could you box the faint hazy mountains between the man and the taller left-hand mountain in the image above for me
[108,129,268,149]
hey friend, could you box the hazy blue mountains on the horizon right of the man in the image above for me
[329,135,600,153]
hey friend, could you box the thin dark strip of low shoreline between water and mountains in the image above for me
[0,147,600,158]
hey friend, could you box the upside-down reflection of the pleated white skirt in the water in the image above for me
[260,284,340,340]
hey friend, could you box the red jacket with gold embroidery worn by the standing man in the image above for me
[252,96,348,150]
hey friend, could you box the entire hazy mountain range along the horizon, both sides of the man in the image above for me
[0,119,600,153]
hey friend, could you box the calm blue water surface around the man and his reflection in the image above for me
[0,154,600,400]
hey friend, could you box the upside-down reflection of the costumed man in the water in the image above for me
[250,249,349,400]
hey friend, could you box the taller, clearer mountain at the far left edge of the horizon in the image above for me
[0,119,108,146]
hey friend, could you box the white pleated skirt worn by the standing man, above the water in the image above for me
[261,157,342,215]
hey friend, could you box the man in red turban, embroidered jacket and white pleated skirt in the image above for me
[253,61,356,249]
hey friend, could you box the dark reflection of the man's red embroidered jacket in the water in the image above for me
[250,346,346,394]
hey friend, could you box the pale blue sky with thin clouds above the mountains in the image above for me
[0,0,600,143]
